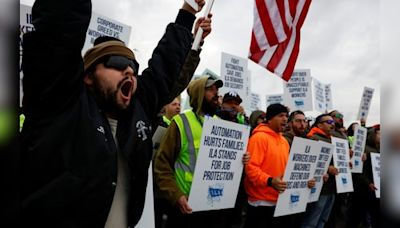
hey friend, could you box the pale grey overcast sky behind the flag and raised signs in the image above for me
[21,0,380,125]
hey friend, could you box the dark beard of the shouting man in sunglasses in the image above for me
[93,76,123,116]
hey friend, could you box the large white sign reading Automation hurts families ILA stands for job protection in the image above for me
[188,117,250,212]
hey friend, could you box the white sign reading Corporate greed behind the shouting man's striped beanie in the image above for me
[82,12,131,54]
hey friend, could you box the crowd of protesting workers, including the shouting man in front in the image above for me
[18,0,380,228]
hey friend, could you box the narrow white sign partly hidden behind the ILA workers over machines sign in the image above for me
[308,141,333,203]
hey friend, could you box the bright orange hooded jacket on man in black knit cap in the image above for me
[244,124,289,202]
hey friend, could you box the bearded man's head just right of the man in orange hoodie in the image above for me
[283,110,307,146]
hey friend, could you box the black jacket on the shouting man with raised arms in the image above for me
[21,0,195,227]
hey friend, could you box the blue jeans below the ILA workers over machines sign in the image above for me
[301,194,335,228]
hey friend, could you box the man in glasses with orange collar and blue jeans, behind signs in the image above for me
[301,114,338,228]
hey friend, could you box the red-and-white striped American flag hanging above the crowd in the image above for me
[249,0,311,81]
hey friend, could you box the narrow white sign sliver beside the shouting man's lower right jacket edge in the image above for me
[135,163,156,228]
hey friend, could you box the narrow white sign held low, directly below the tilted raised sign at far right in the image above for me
[351,124,367,173]
